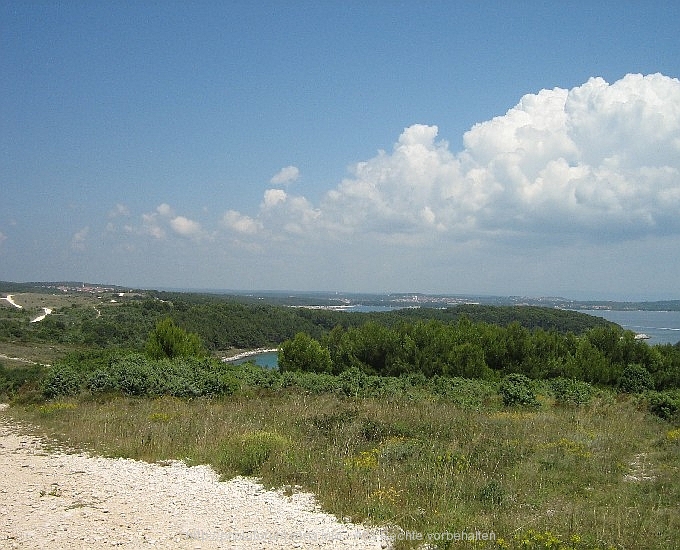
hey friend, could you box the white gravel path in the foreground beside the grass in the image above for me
[0,410,389,550]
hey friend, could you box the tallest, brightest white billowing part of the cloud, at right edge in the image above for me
[460,75,680,238]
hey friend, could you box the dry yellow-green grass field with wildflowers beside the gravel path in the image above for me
[8,387,680,550]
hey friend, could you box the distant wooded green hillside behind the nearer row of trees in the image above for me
[0,287,609,351]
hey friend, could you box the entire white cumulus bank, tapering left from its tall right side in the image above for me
[228,74,680,249]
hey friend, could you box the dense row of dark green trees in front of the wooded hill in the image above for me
[279,316,680,390]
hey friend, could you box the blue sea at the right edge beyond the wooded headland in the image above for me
[579,310,680,346]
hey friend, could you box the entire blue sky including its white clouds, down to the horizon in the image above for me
[0,0,680,299]
